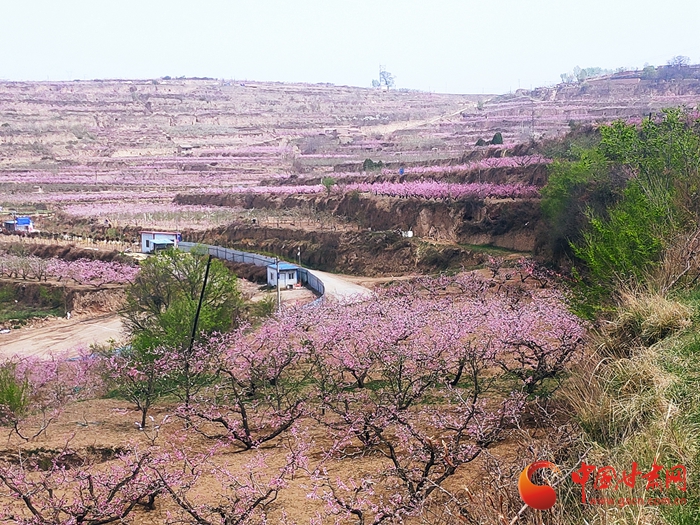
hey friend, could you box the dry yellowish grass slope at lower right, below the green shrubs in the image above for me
[563,288,700,525]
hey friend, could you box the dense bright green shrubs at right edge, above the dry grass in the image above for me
[541,109,700,290]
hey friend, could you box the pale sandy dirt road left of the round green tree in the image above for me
[0,314,122,356]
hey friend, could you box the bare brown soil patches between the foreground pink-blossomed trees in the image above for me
[0,399,544,525]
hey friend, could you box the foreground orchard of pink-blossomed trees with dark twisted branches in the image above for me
[0,274,585,524]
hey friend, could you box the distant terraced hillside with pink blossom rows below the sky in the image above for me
[0,67,700,269]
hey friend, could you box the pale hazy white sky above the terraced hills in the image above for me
[0,0,700,93]
